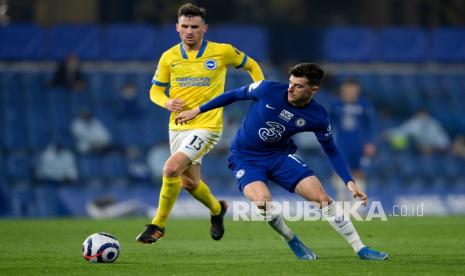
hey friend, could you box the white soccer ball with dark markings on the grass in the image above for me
[82,233,120,263]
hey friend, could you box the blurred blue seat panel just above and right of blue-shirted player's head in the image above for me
[323,27,378,62]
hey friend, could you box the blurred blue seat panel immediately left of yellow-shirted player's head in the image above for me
[104,24,161,60]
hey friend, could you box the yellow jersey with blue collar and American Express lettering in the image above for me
[152,40,263,131]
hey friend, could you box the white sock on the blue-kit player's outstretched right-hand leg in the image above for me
[321,201,365,253]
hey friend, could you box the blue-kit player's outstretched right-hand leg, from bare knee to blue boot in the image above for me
[295,176,388,260]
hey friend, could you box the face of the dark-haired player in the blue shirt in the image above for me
[287,75,319,106]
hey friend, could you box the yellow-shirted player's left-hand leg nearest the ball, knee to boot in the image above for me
[136,152,191,243]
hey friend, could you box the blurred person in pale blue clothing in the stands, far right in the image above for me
[386,108,451,155]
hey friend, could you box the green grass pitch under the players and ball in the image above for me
[0,217,465,275]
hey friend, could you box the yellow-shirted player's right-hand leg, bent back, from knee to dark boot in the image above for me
[182,164,228,240]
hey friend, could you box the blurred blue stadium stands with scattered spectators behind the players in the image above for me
[0,0,465,217]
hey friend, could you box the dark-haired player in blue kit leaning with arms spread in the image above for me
[175,63,388,260]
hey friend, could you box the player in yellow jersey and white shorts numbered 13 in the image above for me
[136,3,264,243]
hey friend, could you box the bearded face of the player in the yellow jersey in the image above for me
[176,16,208,50]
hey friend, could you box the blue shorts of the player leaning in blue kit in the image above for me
[228,152,314,193]
